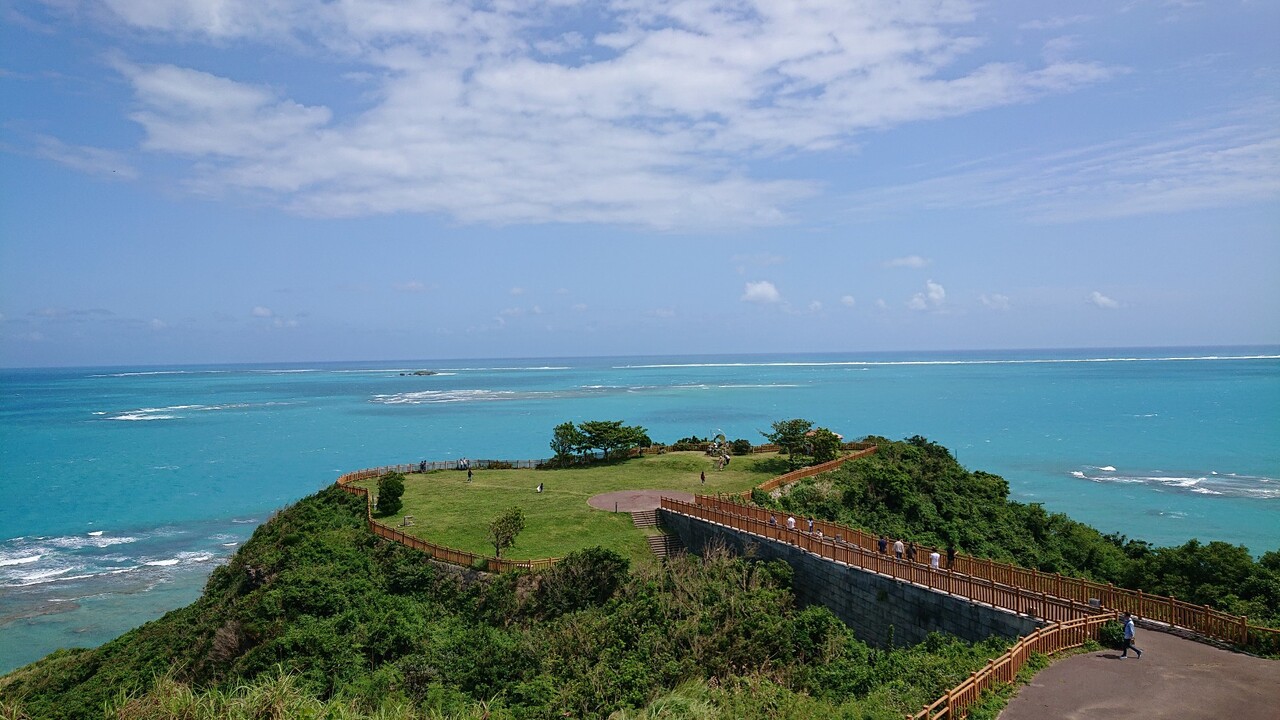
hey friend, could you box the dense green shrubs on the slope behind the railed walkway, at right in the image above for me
[754,437,1280,626]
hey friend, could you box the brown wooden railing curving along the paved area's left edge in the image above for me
[906,611,1117,720]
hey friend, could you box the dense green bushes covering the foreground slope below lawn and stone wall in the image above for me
[0,488,1006,720]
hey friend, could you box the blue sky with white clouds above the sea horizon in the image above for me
[0,0,1280,366]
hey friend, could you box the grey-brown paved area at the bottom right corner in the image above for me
[1000,628,1280,720]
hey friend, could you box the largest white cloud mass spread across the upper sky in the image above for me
[102,0,1111,229]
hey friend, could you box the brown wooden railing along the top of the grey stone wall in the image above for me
[662,497,1098,621]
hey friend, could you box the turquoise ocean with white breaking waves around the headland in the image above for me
[0,347,1280,671]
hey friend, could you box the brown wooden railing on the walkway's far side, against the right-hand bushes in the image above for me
[675,496,1280,652]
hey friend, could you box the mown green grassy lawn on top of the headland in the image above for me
[360,452,786,560]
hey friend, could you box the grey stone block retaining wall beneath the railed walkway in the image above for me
[658,510,1041,647]
